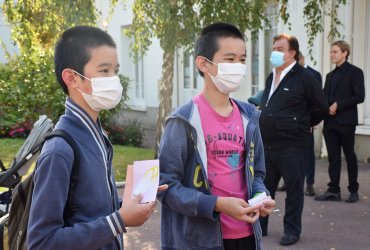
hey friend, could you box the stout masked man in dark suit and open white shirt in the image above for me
[260,34,329,245]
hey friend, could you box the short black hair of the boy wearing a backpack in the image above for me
[54,26,116,94]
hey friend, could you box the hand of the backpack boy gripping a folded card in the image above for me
[119,194,157,227]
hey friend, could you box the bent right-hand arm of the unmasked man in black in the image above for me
[335,68,365,112]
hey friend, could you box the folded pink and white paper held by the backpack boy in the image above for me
[123,160,159,203]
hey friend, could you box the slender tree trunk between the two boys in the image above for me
[154,49,175,158]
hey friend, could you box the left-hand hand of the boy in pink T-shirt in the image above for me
[215,197,262,223]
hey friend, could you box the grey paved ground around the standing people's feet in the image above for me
[121,160,370,250]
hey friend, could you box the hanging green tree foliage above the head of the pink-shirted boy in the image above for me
[130,0,268,58]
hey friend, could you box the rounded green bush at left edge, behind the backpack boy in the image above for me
[0,49,65,131]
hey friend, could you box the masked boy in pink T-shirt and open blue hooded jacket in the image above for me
[158,23,275,250]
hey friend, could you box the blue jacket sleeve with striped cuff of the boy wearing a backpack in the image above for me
[27,143,125,250]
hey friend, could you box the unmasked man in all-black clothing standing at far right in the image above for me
[315,40,365,203]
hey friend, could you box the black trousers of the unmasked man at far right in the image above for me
[323,117,359,193]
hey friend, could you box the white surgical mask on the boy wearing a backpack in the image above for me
[73,70,123,112]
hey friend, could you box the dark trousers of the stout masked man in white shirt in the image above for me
[260,148,307,237]
